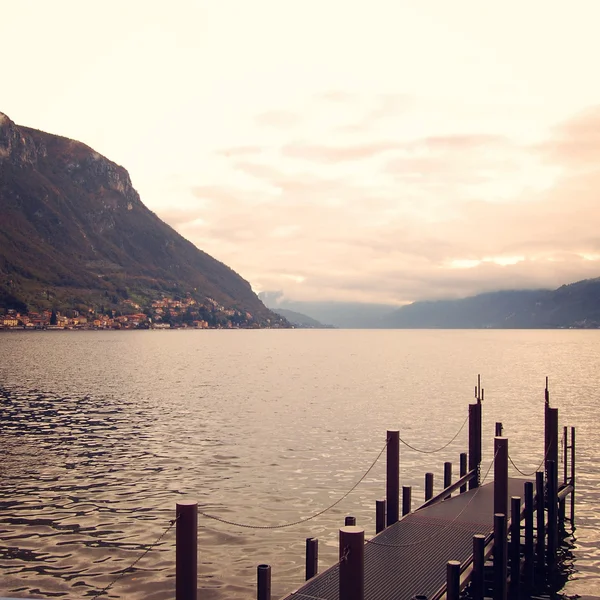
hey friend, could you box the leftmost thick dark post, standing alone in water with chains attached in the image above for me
[175,502,198,600]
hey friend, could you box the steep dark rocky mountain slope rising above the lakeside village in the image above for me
[0,113,285,325]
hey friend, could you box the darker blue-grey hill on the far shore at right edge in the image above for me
[382,278,600,329]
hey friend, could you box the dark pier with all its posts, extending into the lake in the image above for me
[176,380,575,600]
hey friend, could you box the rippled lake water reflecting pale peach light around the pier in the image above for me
[0,330,600,600]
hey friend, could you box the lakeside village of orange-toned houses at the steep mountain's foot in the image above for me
[0,298,282,330]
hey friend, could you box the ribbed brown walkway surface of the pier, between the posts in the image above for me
[286,478,527,600]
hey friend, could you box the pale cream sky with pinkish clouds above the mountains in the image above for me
[0,0,600,304]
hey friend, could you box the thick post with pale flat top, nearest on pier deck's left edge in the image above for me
[339,525,365,600]
